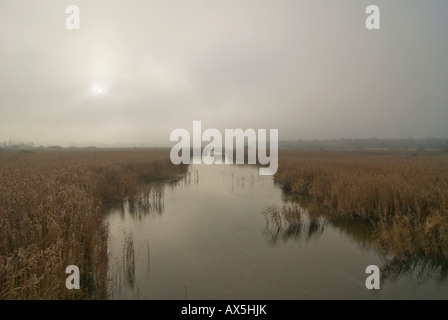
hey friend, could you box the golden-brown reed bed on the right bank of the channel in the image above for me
[275,151,448,270]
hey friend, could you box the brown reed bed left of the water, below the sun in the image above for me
[0,150,185,299]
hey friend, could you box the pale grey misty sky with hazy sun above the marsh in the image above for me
[0,0,448,146]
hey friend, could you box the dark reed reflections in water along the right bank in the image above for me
[263,194,448,283]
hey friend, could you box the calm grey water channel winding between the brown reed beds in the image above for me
[107,165,448,299]
